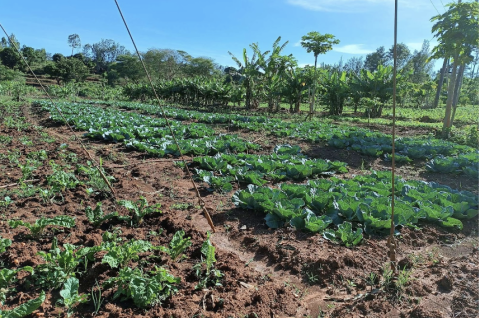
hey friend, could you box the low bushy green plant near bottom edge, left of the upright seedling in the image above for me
[106,267,180,308]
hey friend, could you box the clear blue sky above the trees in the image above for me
[0,0,447,68]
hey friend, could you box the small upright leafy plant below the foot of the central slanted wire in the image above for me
[193,232,223,289]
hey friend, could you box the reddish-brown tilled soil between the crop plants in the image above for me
[0,103,479,318]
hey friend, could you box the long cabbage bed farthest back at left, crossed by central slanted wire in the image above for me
[35,101,260,157]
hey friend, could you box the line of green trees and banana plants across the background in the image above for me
[0,1,479,135]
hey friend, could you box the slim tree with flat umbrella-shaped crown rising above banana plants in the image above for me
[300,31,340,117]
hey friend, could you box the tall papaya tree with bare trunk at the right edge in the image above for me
[431,2,478,138]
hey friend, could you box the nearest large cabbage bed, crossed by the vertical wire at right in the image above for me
[232,172,478,238]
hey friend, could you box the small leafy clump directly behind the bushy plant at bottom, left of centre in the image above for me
[102,240,152,268]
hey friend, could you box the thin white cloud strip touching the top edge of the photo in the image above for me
[287,0,425,12]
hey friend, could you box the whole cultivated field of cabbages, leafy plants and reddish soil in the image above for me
[0,100,479,317]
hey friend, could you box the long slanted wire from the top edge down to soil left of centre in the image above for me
[114,0,215,232]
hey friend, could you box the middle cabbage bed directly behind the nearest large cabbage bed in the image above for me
[193,145,348,193]
